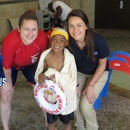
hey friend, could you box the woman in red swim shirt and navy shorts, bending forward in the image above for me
[0,10,49,130]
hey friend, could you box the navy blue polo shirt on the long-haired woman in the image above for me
[74,33,110,75]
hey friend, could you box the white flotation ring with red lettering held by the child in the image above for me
[34,80,67,115]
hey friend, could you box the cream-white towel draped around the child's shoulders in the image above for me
[35,48,77,115]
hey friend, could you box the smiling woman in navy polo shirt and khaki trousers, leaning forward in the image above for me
[67,9,110,130]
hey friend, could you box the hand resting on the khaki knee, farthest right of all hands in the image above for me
[82,85,96,103]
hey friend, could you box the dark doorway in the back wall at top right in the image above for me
[95,0,130,29]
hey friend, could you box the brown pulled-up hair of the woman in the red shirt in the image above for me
[18,9,38,27]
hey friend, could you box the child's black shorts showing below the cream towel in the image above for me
[47,112,74,124]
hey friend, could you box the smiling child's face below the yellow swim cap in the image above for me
[50,34,68,51]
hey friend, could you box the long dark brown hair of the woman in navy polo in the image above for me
[66,9,95,60]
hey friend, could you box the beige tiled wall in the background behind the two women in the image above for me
[0,0,95,41]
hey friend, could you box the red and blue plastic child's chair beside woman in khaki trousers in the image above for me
[93,51,130,109]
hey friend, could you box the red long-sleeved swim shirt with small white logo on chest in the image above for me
[2,29,49,69]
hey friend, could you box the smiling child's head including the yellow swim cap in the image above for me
[50,28,68,50]
